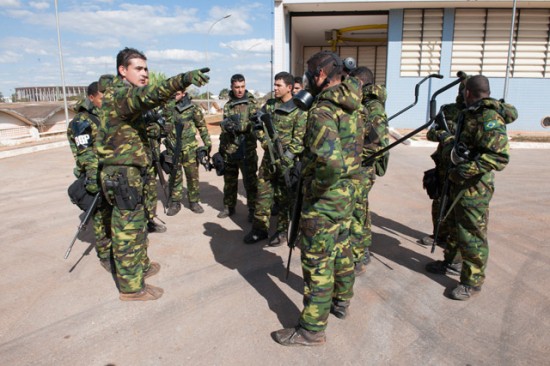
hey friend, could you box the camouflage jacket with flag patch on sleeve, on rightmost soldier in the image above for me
[456,98,517,179]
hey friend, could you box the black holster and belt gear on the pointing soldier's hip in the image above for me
[103,165,147,210]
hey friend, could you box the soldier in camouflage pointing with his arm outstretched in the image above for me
[97,48,208,301]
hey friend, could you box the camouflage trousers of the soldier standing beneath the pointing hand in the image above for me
[170,149,200,203]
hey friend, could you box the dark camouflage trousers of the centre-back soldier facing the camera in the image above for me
[223,150,258,210]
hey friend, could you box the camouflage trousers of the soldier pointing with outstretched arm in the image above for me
[101,165,150,293]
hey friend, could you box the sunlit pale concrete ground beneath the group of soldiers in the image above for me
[0,138,550,366]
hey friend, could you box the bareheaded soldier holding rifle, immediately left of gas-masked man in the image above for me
[244,72,307,246]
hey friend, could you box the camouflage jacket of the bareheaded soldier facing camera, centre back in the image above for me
[220,91,258,154]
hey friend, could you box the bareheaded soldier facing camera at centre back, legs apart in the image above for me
[218,74,258,222]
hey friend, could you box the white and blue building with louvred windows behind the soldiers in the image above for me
[273,0,550,130]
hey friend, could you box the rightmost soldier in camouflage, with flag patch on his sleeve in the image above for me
[426,75,517,300]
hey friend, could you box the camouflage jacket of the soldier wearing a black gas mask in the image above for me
[302,78,364,198]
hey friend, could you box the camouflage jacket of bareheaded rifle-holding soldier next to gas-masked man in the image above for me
[257,98,307,165]
